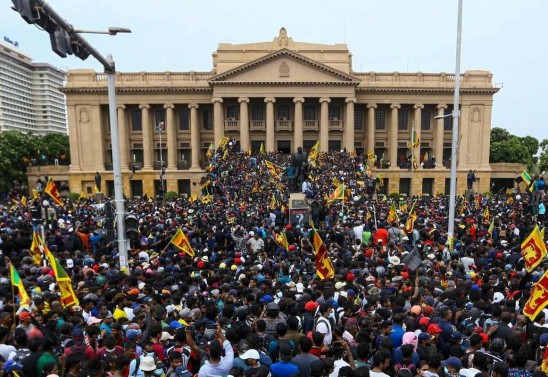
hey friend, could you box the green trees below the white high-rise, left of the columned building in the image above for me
[0,131,70,193]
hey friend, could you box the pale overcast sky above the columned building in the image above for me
[0,0,548,141]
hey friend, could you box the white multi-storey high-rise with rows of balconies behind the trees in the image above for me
[0,41,67,135]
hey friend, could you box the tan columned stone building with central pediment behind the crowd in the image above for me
[63,28,498,196]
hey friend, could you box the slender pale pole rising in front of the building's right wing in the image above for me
[435,0,462,245]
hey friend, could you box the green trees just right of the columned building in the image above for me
[489,127,539,169]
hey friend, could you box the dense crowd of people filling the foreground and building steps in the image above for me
[0,143,548,377]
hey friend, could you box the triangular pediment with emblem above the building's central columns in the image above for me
[208,49,359,85]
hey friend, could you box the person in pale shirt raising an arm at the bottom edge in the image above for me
[198,324,233,377]
